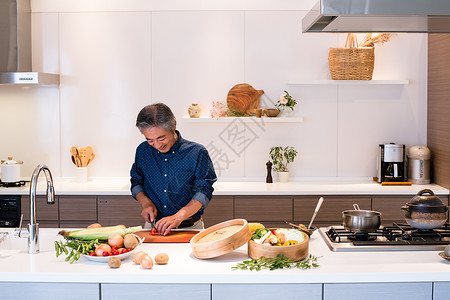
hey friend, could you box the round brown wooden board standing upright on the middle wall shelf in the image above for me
[227,83,264,112]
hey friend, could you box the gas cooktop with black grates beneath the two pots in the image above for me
[319,223,450,252]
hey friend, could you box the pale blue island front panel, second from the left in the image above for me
[101,283,211,300]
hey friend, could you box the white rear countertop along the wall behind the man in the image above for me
[0,178,449,196]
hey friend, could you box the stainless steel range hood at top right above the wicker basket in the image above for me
[302,0,450,33]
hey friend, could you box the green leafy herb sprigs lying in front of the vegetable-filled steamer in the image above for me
[231,254,319,271]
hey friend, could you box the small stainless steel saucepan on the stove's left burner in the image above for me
[342,204,381,233]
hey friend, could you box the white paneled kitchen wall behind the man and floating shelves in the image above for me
[0,0,427,180]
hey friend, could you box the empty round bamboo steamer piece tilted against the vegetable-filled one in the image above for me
[190,219,252,258]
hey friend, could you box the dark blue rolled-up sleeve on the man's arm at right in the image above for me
[193,149,217,208]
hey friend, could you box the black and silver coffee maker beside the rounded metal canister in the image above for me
[378,143,406,182]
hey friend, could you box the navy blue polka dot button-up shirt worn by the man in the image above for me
[130,131,217,220]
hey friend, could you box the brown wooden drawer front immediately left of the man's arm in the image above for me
[98,196,145,227]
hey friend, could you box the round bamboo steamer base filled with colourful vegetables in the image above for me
[248,228,309,261]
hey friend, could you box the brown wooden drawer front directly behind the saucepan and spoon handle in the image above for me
[294,195,371,227]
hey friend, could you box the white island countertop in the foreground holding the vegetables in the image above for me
[0,228,450,283]
